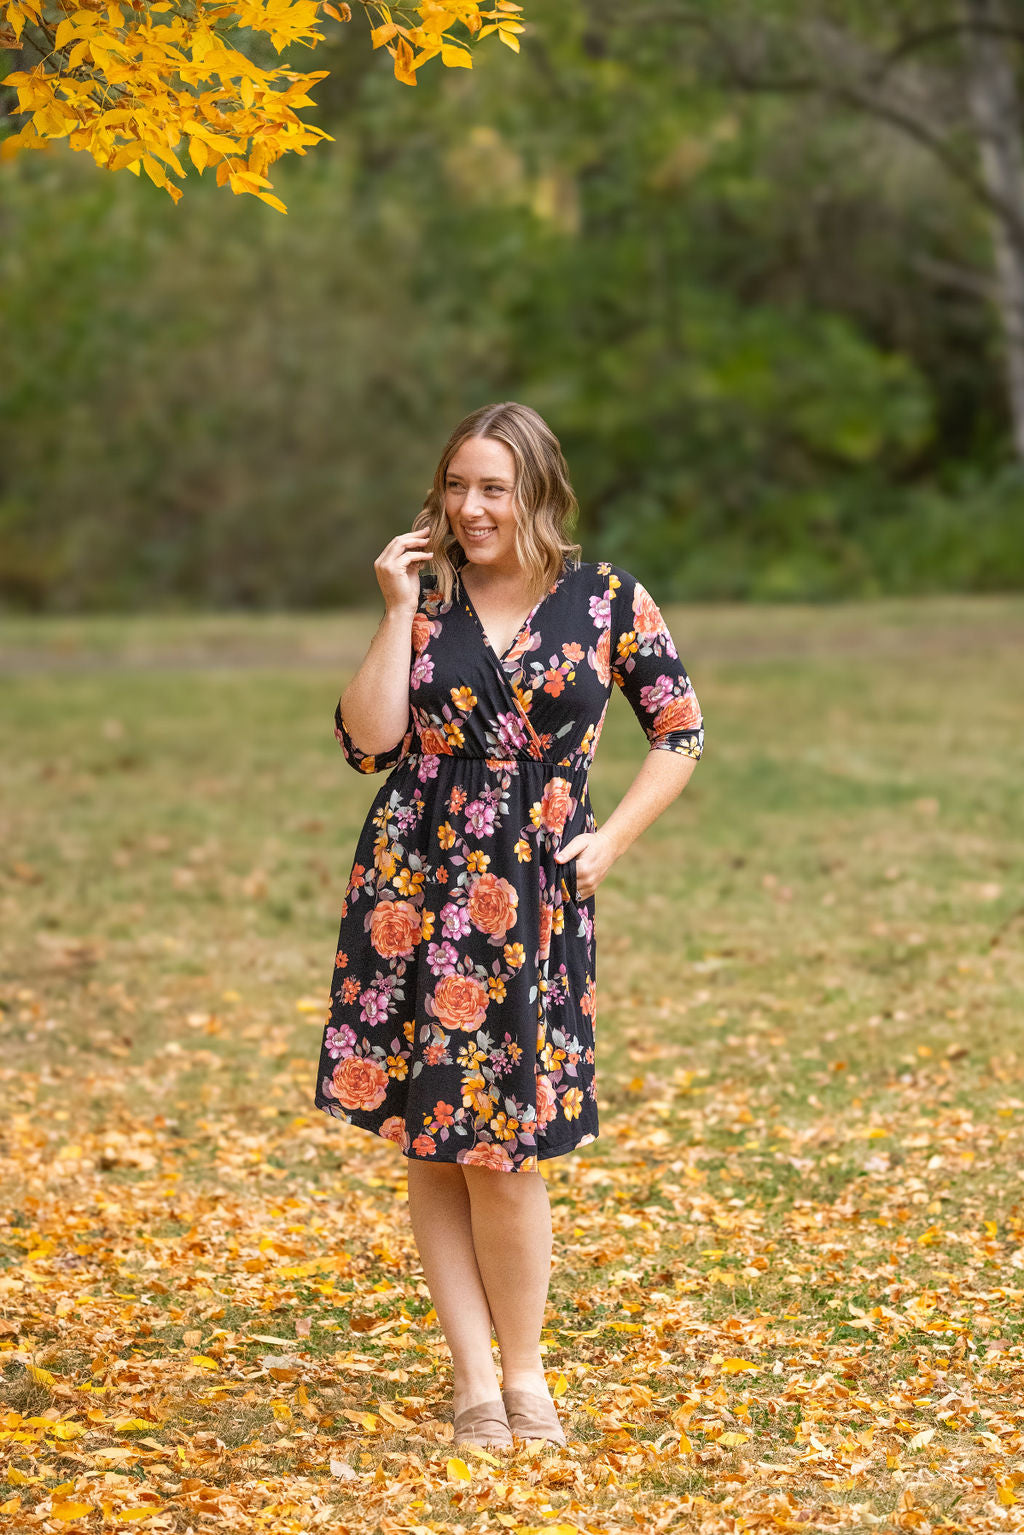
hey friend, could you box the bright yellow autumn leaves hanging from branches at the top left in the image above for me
[0,0,524,213]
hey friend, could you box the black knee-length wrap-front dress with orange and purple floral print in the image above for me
[316,560,703,1171]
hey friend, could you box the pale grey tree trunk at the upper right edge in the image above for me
[963,0,1024,461]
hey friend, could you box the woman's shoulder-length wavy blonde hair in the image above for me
[413,399,583,605]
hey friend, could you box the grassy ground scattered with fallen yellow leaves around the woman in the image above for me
[0,599,1024,1535]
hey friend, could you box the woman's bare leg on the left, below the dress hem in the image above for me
[407,1157,510,1414]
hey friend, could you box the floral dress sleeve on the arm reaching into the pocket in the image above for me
[608,565,705,757]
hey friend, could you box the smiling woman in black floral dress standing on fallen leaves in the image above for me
[316,402,703,1446]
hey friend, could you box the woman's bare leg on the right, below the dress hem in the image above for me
[465,1165,551,1398]
